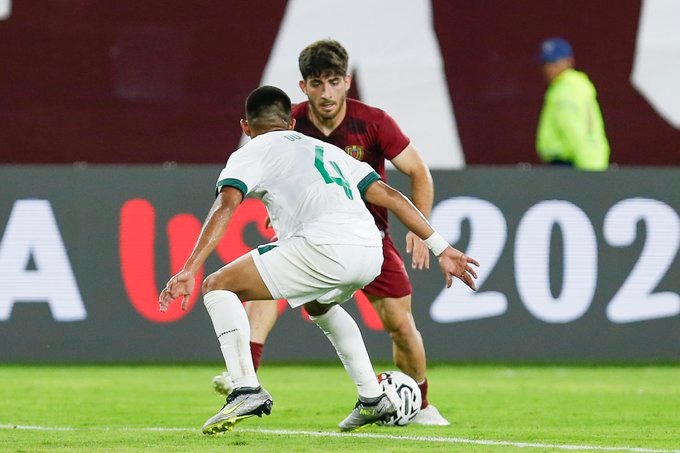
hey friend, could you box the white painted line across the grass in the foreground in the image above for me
[0,424,680,453]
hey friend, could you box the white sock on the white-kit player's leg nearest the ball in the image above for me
[310,305,383,398]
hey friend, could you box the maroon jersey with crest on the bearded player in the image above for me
[292,99,410,232]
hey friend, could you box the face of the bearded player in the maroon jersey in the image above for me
[300,74,351,121]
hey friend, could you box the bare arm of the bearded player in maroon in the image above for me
[392,144,434,269]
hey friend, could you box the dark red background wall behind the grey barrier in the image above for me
[0,0,680,165]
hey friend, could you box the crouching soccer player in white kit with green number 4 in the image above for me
[159,86,479,434]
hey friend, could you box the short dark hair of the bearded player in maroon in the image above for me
[298,39,349,80]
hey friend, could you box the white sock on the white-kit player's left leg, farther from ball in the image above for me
[203,290,260,388]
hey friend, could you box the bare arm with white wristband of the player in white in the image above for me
[364,181,479,291]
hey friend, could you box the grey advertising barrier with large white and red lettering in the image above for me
[0,165,680,363]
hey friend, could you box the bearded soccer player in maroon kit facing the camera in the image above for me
[213,40,449,425]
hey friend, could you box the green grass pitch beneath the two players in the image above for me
[0,363,680,453]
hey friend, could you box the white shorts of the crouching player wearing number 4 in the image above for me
[250,237,383,308]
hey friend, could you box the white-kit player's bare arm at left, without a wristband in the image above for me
[158,186,243,312]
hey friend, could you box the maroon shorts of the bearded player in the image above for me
[364,234,413,298]
